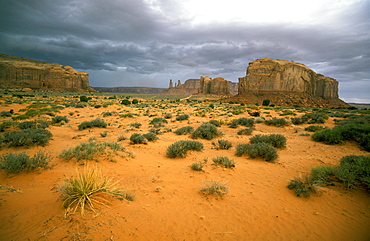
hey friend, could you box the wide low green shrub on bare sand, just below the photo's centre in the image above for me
[166,140,203,158]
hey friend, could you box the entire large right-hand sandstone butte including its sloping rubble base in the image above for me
[228,58,348,107]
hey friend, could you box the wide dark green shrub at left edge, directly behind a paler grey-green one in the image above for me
[3,129,53,147]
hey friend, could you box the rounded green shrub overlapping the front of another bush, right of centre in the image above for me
[235,143,278,162]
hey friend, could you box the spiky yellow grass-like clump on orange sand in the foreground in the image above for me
[60,167,124,215]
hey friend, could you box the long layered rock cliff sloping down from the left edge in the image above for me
[0,54,93,91]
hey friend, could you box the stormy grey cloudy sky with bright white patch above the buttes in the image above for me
[0,0,370,103]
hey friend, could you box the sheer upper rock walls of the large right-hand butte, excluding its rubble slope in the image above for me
[239,58,338,99]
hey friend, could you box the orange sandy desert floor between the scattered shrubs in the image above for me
[0,94,370,241]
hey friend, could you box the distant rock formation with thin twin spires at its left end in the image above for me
[162,76,239,95]
